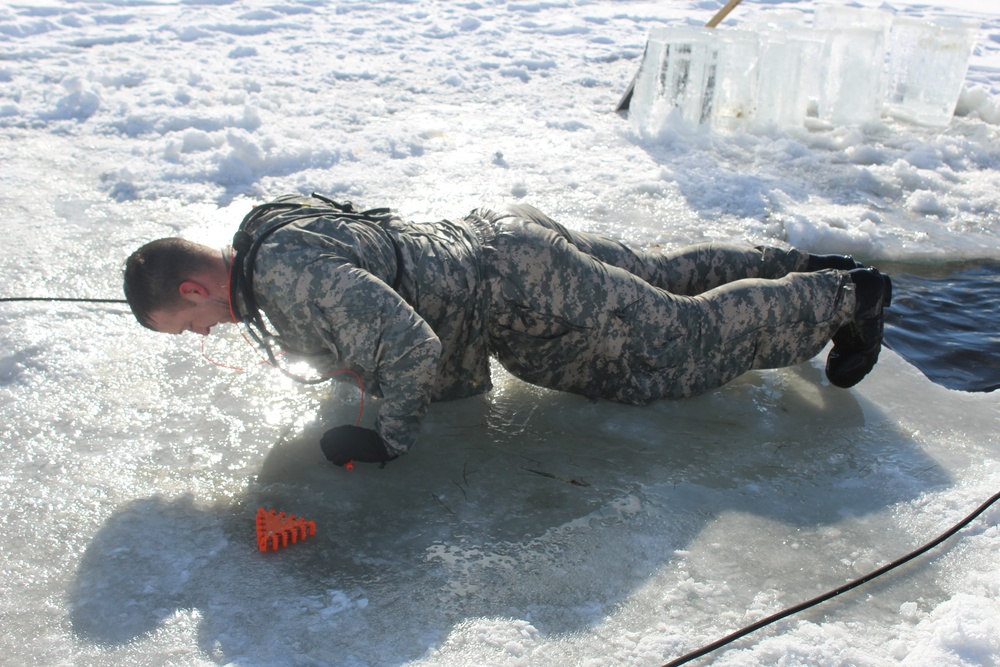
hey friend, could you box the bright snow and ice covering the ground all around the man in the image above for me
[0,0,1000,667]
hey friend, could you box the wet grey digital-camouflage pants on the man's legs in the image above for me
[480,206,855,404]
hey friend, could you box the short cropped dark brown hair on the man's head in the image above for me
[124,237,216,329]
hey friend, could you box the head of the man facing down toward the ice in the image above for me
[124,238,233,335]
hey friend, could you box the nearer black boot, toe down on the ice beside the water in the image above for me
[826,269,892,389]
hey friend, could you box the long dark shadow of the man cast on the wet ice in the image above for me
[71,352,950,665]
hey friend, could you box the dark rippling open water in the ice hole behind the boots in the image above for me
[879,262,1000,391]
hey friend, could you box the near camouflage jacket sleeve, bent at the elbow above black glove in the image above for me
[294,259,441,454]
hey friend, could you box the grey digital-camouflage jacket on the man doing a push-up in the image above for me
[238,195,491,453]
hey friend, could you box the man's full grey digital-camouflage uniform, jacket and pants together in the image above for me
[240,197,854,453]
